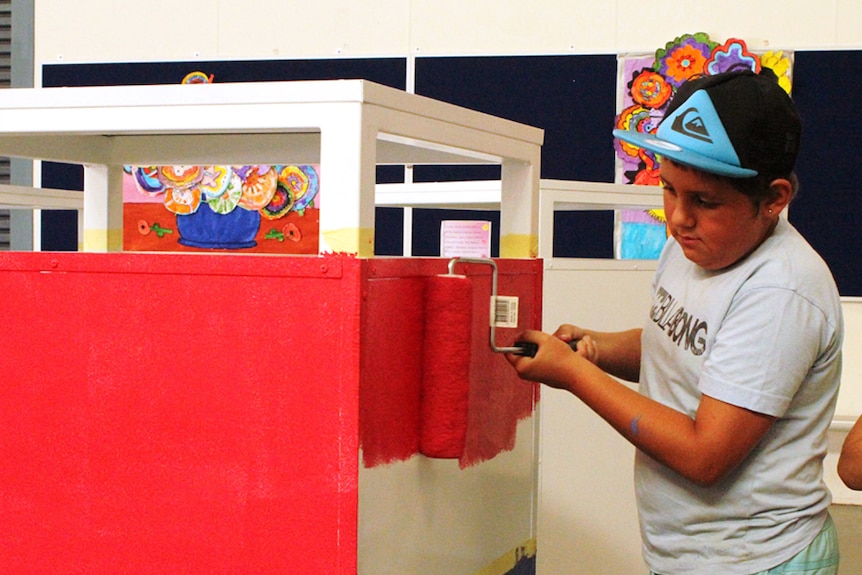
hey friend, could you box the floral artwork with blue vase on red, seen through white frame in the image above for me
[123,72,320,254]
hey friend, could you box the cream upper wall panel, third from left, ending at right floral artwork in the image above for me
[410,0,616,56]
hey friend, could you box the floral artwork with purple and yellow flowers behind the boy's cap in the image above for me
[614,32,793,259]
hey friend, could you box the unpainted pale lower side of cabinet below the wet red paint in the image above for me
[357,416,537,575]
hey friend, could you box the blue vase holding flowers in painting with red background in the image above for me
[177,205,260,250]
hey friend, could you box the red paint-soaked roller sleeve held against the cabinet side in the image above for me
[419,275,473,459]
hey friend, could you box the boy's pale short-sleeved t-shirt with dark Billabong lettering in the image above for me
[635,219,843,575]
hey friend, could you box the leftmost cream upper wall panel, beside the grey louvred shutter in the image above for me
[34,0,221,65]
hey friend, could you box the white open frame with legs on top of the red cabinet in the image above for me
[0,80,544,257]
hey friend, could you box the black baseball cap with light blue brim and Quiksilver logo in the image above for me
[613,69,802,178]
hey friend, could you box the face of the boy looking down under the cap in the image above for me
[661,161,776,270]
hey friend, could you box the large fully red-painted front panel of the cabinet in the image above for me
[0,253,361,575]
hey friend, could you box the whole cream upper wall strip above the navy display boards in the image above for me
[35,0,862,67]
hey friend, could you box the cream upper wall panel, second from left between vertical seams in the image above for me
[218,0,410,59]
